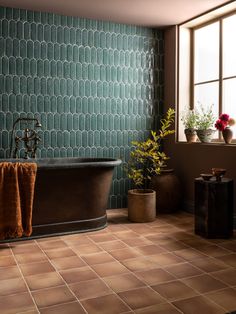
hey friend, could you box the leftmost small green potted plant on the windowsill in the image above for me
[181,108,198,143]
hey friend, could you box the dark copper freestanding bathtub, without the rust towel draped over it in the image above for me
[2,157,121,236]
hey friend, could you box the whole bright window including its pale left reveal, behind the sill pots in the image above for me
[178,6,236,141]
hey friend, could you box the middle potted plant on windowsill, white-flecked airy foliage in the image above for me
[197,105,215,143]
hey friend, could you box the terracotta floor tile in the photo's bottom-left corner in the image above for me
[0,292,36,314]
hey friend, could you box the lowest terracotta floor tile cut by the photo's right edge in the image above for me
[206,288,236,311]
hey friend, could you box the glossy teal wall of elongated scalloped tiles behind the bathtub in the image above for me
[0,7,164,208]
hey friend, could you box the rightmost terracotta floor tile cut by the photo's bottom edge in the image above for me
[173,296,225,314]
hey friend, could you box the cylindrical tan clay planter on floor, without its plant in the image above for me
[128,189,156,222]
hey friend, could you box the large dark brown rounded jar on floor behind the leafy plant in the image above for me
[150,169,181,215]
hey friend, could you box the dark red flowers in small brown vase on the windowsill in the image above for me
[215,113,235,144]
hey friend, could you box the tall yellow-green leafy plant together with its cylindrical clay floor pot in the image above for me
[127,108,175,222]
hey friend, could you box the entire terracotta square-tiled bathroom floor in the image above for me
[0,210,236,314]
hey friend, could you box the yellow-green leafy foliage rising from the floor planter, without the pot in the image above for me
[127,108,175,188]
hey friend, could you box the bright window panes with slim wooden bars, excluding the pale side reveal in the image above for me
[192,14,236,137]
